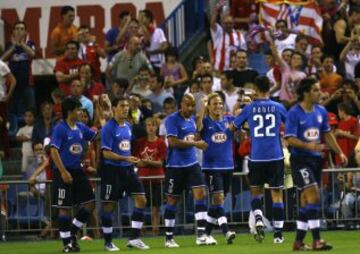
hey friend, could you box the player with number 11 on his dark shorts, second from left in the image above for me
[101,97,149,251]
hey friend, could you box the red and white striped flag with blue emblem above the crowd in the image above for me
[259,0,323,44]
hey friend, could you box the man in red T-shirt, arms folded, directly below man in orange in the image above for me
[55,41,83,96]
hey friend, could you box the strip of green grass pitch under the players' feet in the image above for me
[0,231,360,254]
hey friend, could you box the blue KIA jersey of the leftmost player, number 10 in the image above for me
[50,121,97,169]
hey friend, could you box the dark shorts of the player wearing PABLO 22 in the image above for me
[249,160,284,189]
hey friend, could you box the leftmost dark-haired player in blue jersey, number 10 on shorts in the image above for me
[51,98,97,253]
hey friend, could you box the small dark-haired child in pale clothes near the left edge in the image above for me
[16,110,35,172]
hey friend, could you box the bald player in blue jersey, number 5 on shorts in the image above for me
[164,94,207,248]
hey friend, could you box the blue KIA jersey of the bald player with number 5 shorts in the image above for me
[165,112,198,168]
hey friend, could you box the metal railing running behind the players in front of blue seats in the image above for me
[0,168,360,238]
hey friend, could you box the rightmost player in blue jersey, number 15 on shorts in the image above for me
[285,78,347,250]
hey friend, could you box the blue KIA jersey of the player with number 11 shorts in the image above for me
[101,118,132,167]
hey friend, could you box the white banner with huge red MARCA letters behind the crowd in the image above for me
[0,0,181,74]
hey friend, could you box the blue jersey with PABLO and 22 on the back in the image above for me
[234,99,286,161]
